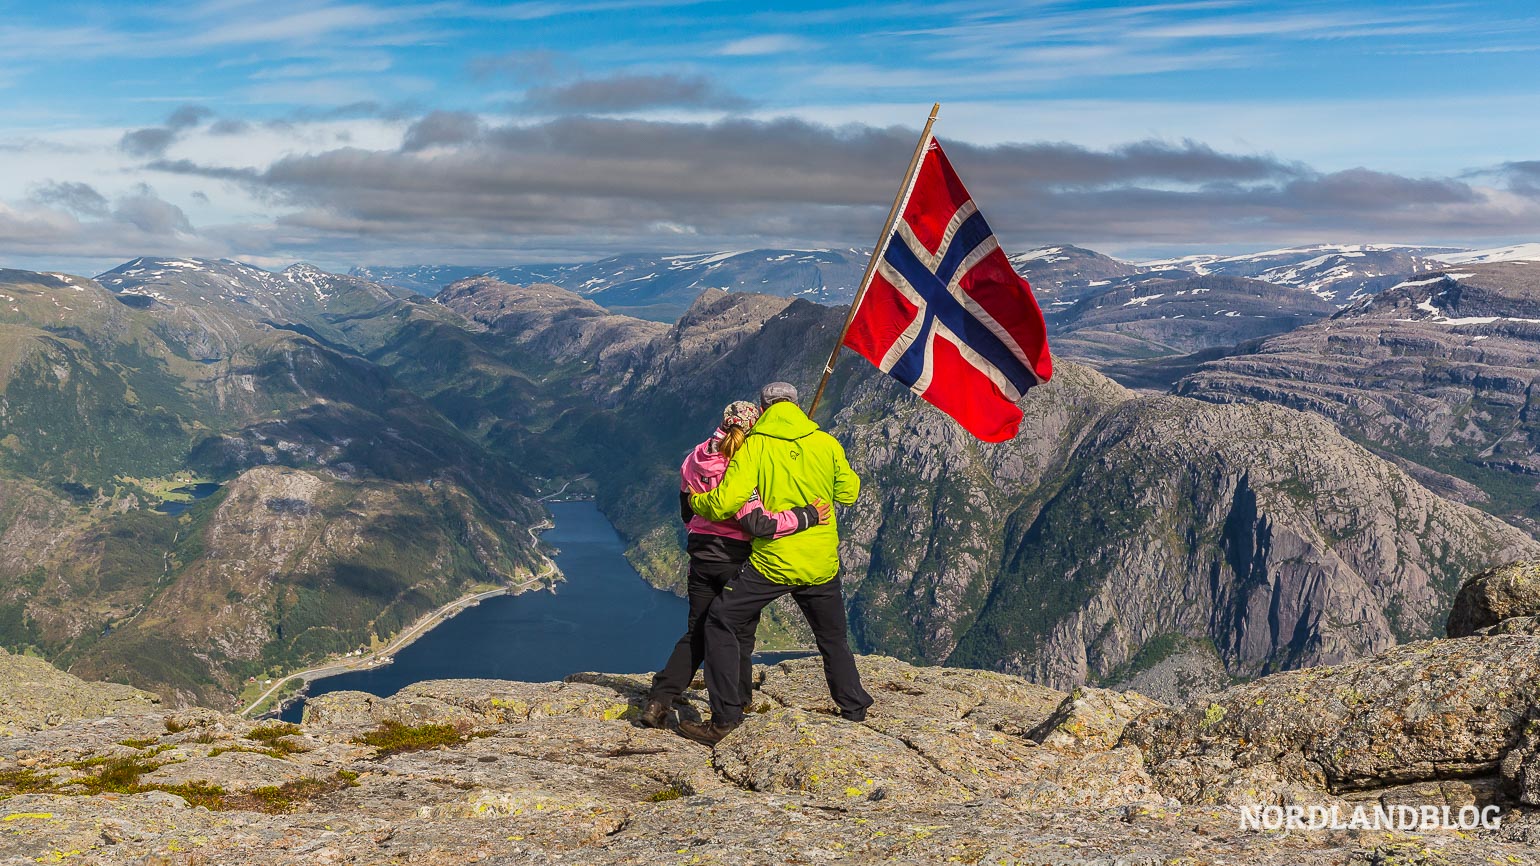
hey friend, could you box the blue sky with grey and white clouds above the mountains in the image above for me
[0,0,1540,270]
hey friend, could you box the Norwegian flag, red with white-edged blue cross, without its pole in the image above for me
[844,139,1053,442]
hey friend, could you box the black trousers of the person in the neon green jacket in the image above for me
[705,562,872,724]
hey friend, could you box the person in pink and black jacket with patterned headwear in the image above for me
[641,401,830,727]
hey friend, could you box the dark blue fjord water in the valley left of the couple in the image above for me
[283,502,687,721]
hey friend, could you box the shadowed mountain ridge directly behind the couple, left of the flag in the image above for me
[439,279,842,619]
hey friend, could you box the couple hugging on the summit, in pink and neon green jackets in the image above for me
[642,382,872,746]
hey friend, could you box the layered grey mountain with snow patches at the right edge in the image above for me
[1177,262,1540,532]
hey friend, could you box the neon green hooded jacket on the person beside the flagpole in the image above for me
[690,402,861,586]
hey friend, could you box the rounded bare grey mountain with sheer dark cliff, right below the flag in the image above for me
[949,398,1540,684]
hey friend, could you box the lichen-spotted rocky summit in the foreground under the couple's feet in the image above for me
[9,563,1540,866]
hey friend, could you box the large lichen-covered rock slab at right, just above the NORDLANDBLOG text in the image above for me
[1123,635,1540,804]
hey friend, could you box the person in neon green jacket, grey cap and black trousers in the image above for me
[679,382,872,746]
